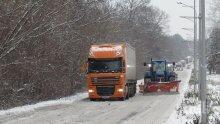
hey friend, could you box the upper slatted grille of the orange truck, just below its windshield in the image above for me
[92,77,119,84]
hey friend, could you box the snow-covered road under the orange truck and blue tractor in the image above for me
[0,69,191,124]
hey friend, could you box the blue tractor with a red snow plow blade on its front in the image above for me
[139,59,181,93]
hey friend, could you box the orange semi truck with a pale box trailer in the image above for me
[87,43,137,101]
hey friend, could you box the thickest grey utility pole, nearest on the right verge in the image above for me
[199,0,208,124]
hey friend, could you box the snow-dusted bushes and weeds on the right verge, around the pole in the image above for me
[176,73,220,124]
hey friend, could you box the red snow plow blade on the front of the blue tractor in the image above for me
[139,81,181,93]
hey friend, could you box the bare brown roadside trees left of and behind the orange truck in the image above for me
[0,0,190,109]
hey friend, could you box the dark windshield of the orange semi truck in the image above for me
[88,58,122,73]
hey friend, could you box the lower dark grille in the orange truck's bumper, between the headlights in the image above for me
[96,86,115,96]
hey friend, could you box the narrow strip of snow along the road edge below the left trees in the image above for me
[0,93,88,116]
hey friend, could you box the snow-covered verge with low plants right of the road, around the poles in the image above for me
[165,72,220,124]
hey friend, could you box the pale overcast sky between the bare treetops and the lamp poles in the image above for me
[151,0,198,39]
